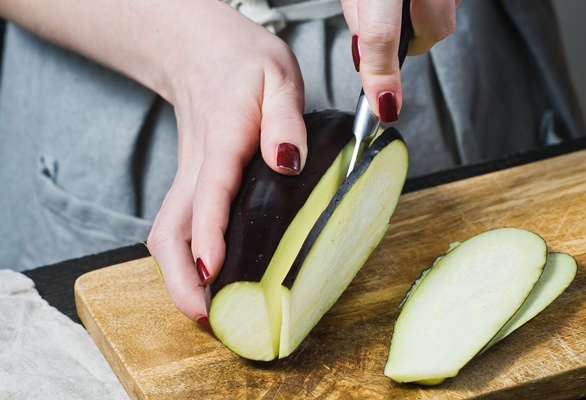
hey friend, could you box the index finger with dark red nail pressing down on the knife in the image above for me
[357,0,402,122]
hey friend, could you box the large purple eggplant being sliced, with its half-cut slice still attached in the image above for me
[209,111,408,361]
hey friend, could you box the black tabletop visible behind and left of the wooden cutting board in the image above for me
[24,137,586,323]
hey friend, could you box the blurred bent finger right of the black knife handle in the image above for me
[409,0,460,55]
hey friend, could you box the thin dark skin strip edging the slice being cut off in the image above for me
[283,127,404,290]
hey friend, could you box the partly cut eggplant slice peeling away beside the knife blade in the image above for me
[279,127,409,358]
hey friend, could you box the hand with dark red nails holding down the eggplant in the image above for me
[147,1,307,326]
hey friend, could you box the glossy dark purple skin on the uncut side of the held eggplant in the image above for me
[209,110,354,298]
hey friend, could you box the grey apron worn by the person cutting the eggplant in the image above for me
[0,0,585,270]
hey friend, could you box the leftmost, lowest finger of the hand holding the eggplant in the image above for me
[147,181,207,321]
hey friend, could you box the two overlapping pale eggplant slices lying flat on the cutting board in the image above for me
[384,227,577,385]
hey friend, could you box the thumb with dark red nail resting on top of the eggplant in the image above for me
[260,52,307,175]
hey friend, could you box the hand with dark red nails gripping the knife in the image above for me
[341,0,460,122]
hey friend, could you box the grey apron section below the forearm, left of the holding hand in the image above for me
[0,25,176,270]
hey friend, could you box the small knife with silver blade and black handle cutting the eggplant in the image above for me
[346,0,413,176]
